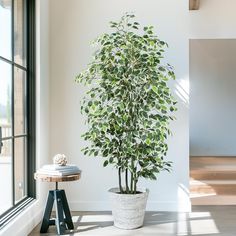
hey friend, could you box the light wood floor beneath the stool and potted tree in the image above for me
[30,206,236,236]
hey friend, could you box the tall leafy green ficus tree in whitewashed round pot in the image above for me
[76,14,176,229]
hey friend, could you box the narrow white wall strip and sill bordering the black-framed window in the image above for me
[0,0,49,236]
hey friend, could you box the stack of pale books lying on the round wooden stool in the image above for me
[37,164,81,176]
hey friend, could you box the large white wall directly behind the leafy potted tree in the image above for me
[50,0,190,210]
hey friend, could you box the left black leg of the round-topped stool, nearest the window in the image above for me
[40,191,54,233]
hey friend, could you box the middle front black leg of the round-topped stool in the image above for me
[54,190,66,235]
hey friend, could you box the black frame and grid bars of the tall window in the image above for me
[0,0,36,229]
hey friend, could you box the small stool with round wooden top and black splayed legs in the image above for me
[34,173,80,235]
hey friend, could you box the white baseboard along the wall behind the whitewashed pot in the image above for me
[69,201,191,212]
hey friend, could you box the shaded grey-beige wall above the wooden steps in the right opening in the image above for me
[190,39,236,156]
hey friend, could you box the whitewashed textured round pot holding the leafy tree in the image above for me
[109,188,149,229]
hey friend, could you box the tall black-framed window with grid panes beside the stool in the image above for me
[0,0,35,226]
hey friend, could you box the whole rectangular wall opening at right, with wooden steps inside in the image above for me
[190,39,236,205]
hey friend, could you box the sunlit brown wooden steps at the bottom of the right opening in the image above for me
[190,157,236,205]
